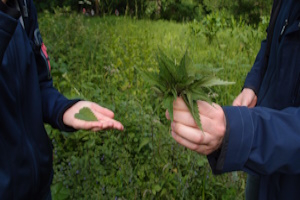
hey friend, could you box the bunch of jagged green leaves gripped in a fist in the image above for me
[140,49,234,129]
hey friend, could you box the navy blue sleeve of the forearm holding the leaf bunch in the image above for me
[209,106,300,175]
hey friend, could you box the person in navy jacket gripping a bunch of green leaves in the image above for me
[166,0,300,200]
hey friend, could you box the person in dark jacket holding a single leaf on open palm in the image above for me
[0,0,123,200]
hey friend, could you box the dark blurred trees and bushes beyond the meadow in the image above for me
[35,0,272,24]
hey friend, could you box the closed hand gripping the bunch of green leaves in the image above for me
[166,98,226,155]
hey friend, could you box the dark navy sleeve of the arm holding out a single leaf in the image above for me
[27,1,79,131]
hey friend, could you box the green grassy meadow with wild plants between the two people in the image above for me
[39,11,267,200]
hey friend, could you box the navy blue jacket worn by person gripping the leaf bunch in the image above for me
[208,0,300,200]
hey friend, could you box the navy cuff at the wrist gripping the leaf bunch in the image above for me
[208,106,254,174]
